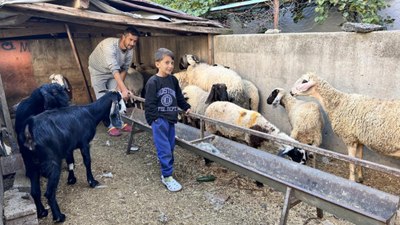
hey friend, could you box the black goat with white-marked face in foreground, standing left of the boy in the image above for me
[22,92,122,222]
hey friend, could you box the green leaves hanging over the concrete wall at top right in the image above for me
[292,0,393,25]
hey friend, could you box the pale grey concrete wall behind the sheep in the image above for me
[214,31,400,168]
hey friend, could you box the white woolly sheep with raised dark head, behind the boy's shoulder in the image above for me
[180,55,249,109]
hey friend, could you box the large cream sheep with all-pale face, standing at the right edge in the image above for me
[291,73,400,182]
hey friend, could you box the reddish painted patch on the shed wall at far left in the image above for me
[0,40,38,106]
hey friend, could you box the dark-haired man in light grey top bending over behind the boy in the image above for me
[89,27,140,136]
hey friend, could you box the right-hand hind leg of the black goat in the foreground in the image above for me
[45,162,65,222]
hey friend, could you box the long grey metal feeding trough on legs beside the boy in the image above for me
[124,108,399,225]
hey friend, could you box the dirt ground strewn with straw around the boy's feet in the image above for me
[35,125,400,225]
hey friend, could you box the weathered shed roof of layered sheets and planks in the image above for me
[0,0,230,37]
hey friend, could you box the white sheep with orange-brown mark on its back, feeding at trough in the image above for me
[204,101,307,164]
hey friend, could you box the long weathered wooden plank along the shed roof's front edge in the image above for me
[3,3,230,34]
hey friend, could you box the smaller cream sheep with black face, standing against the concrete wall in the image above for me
[267,88,324,147]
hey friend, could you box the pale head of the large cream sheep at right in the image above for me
[290,73,318,96]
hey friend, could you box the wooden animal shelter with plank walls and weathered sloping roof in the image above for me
[0,0,230,106]
